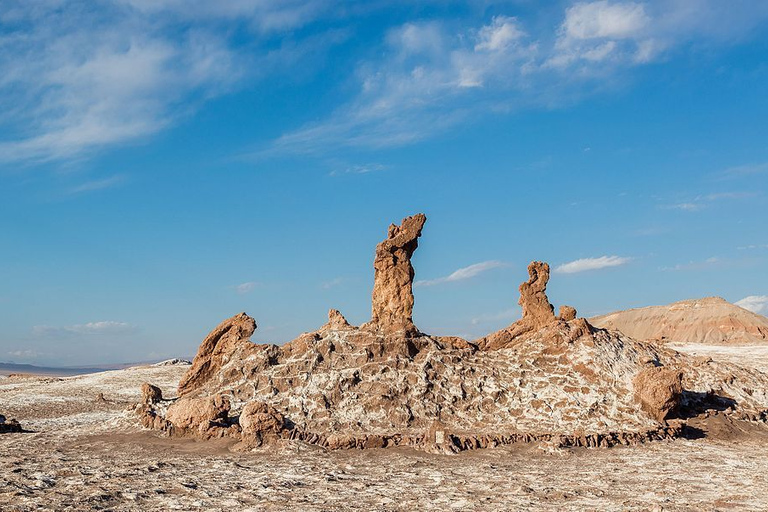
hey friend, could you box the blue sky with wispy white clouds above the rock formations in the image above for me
[0,0,768,365]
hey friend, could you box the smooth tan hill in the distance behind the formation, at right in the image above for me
[589,297,768,345]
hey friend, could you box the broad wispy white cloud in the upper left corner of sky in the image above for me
[0,0,331,163]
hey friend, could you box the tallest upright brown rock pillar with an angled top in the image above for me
[367,213,427,336]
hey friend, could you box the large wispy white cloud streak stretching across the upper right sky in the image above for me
[263,0,768,154]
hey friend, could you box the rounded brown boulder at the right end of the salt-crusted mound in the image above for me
[632,366,683,421]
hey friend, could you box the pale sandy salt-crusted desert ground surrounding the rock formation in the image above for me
[0,352,768,511]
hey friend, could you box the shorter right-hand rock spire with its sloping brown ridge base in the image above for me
[476,261,590,350]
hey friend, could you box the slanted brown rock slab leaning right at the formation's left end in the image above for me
[179,313,256,396]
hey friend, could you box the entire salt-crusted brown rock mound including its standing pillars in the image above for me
[137,215,768,453]
